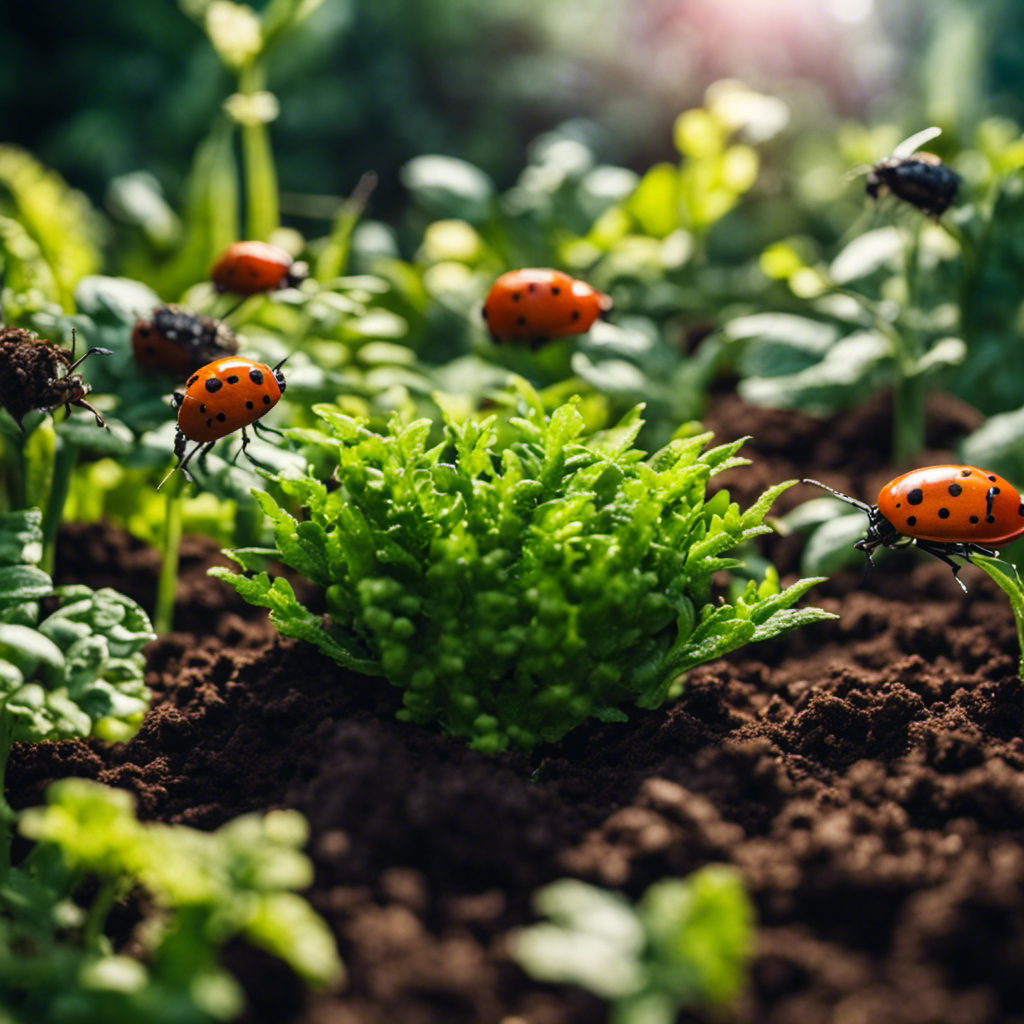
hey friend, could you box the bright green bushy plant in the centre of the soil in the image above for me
[212,381,828,751]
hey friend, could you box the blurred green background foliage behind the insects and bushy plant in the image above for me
[0,0,1024,561]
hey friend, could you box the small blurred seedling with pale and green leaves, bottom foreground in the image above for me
[511,864,754,1024]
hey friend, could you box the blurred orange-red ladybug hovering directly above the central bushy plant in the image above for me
[483,267,611,349]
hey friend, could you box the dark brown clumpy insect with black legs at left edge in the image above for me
[0,327,111,430]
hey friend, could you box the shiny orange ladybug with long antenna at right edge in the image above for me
[803,465,1024,591]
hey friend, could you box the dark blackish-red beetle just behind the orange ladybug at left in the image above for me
[131,306,239,377]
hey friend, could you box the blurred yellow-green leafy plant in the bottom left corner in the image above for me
[0,779,343,1024]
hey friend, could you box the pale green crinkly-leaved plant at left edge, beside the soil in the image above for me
[0,509,155,879]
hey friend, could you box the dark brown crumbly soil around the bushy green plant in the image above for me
[10,389,1024,1024]
